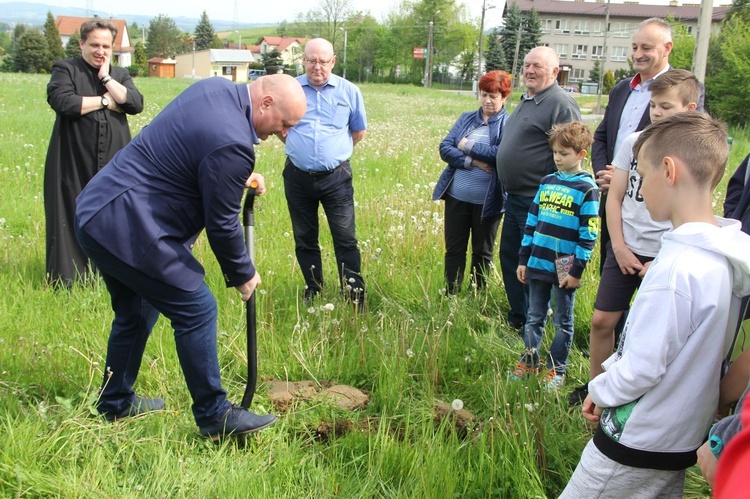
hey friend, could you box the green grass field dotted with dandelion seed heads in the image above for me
[0,74,750,498]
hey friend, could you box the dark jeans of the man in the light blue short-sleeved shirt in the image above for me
[284,159,365,297]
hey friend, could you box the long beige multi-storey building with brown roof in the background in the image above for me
[506,0,729,87]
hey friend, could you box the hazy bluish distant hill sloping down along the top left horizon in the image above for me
[0,2,273,33]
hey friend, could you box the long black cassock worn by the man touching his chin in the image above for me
[44,56,143,286]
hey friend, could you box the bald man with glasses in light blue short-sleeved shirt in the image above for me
[284,38,367,311]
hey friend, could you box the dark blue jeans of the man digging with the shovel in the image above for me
[75,219,231,427]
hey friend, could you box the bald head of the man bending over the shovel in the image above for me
[249,74,307,140]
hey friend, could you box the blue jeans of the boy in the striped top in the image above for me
[521,279,576,374]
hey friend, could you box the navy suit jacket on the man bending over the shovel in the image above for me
[76,78,258,291]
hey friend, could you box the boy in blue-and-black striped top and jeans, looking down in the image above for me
[510,121,599,390]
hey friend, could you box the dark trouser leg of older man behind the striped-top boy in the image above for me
[500,194,534,324]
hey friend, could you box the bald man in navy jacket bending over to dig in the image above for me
[75,75,306,440]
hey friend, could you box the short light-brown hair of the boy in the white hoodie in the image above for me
[633,112,729,189]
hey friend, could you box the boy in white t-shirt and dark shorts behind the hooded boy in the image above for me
[589,69,701,386]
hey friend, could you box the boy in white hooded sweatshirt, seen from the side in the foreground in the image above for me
[561,113,750,498]
